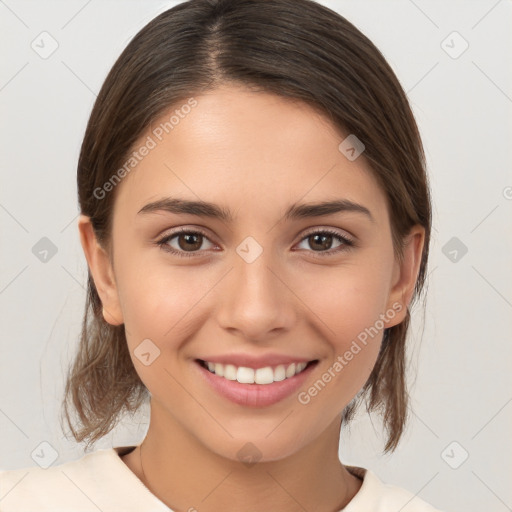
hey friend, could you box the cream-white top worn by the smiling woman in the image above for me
[0,446,440,512]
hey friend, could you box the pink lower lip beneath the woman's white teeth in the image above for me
[194,361,318,407]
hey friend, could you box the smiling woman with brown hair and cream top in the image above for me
[0,0,444,512]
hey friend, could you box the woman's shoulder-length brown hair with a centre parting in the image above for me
[63,0,431,452]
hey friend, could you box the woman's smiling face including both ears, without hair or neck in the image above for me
[82,86,422,460]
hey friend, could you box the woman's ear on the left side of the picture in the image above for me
[78,215,123,325]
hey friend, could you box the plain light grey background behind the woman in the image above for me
[0,0,512,512]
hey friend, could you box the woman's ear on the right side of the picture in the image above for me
[385,225,425,328]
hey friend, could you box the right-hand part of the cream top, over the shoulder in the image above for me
[343,466,441,512]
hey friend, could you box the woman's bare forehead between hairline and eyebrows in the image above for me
[110,86,385,225]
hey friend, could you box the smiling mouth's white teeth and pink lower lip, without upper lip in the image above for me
[194,359,319,407]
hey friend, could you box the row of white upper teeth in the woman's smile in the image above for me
[202,362,307,384]
